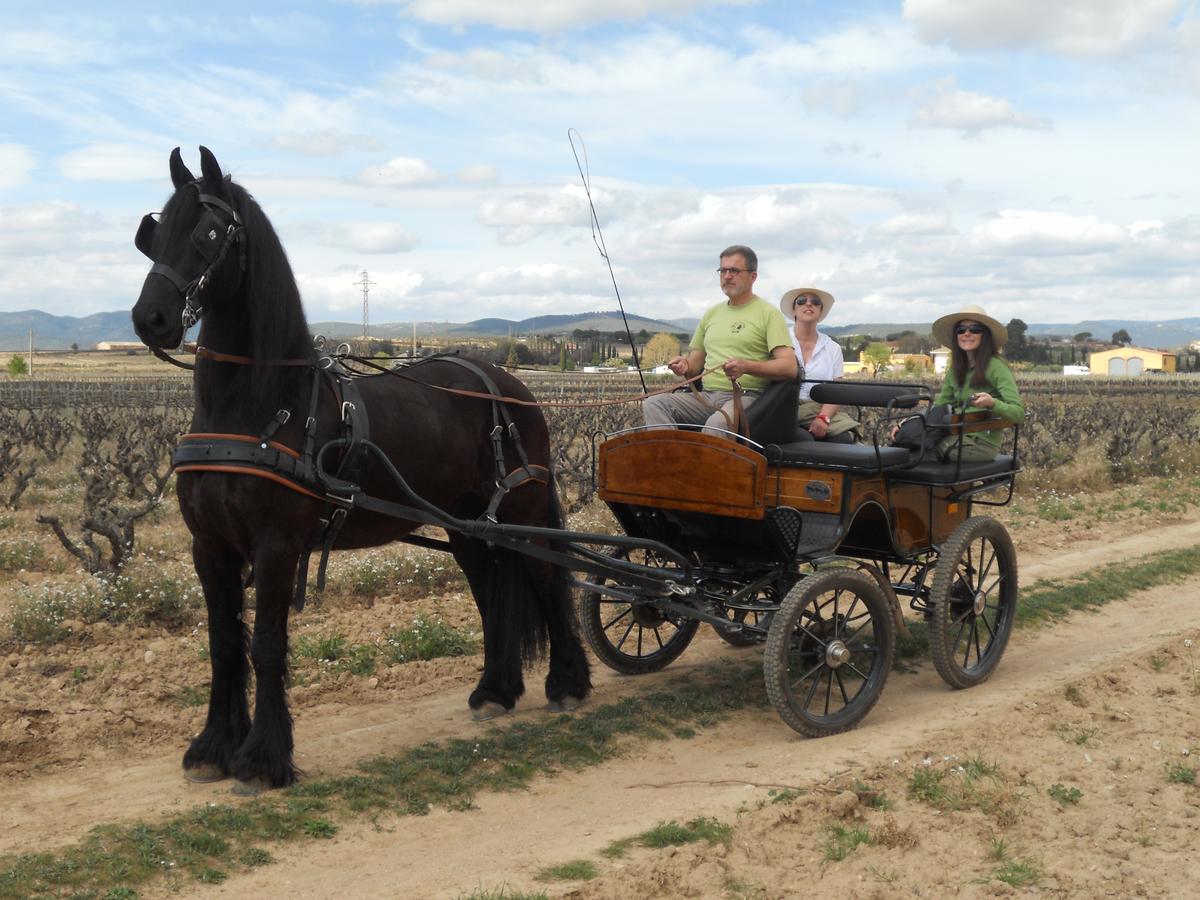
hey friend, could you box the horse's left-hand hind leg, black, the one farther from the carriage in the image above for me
[450,534,524,719]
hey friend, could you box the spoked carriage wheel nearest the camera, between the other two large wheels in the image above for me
[762,569,895,738]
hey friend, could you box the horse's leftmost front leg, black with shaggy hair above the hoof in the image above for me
[184,538,250,781]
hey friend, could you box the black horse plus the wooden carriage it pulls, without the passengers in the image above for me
[132,148,1019,793]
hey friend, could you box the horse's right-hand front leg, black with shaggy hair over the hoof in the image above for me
[232,547,300,793]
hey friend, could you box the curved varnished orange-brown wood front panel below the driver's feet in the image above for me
[599,428,767,518]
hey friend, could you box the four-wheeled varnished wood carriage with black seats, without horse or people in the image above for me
[570,382,1020,737]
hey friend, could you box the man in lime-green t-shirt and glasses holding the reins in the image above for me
[642,245,798,434]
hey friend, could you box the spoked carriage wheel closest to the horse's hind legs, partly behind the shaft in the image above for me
[580,550,700,674]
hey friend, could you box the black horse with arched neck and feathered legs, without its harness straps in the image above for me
[133,146,590,792]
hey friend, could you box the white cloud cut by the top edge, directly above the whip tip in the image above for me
[403,0,758,31]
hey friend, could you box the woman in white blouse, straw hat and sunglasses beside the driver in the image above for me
[779,288,858,444]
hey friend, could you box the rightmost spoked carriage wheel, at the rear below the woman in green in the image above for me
[929,516,1016,688]
